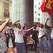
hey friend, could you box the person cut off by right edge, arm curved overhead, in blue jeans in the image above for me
[45,13,53,53]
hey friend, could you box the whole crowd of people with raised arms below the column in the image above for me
[0,18,53,53]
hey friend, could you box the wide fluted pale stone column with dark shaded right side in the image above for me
[11,0,33,26]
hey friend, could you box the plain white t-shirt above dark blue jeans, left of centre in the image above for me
[14,28,25,43]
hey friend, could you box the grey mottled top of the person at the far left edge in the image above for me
[0,32,7,53]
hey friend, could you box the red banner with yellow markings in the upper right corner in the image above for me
[41,0,53,15]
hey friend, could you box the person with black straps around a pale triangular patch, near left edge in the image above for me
[5,22,15,53]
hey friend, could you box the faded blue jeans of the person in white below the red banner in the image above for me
[39,37,51,53]
